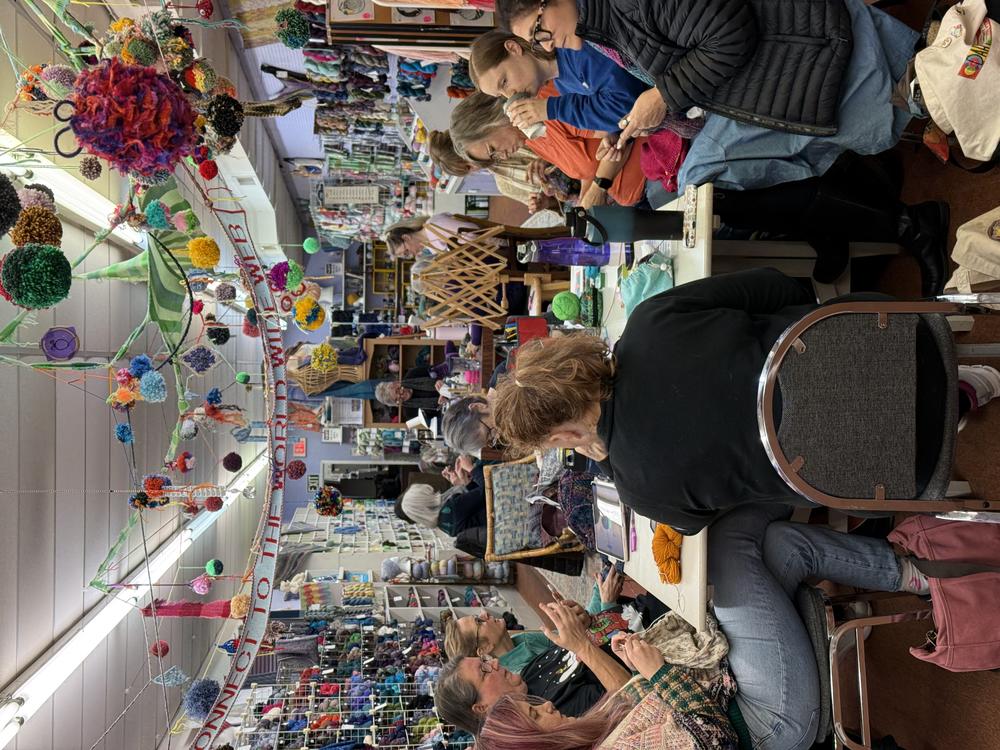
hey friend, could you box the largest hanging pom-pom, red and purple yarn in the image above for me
[70,58,197,177]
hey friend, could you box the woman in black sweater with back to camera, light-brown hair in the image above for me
[492,269,1000,534]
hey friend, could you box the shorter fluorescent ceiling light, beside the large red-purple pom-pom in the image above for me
[0,128,145,247]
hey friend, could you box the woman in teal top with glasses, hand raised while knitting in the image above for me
[444,568,622,674]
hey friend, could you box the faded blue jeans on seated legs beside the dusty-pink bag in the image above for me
[708,504,900,750]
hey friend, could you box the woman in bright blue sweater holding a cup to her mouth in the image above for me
[469,29,647,136]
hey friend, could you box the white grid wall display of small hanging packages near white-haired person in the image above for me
[283,498,446,557]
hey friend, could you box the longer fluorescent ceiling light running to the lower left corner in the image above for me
[0,450,269,750]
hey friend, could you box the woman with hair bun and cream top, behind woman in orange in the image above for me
[427,130,580,213]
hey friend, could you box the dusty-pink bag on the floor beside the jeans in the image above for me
[889,516,1000,672]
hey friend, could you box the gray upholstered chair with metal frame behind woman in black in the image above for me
[757,295,1000,512]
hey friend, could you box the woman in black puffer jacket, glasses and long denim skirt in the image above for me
[497,0,918,206]
